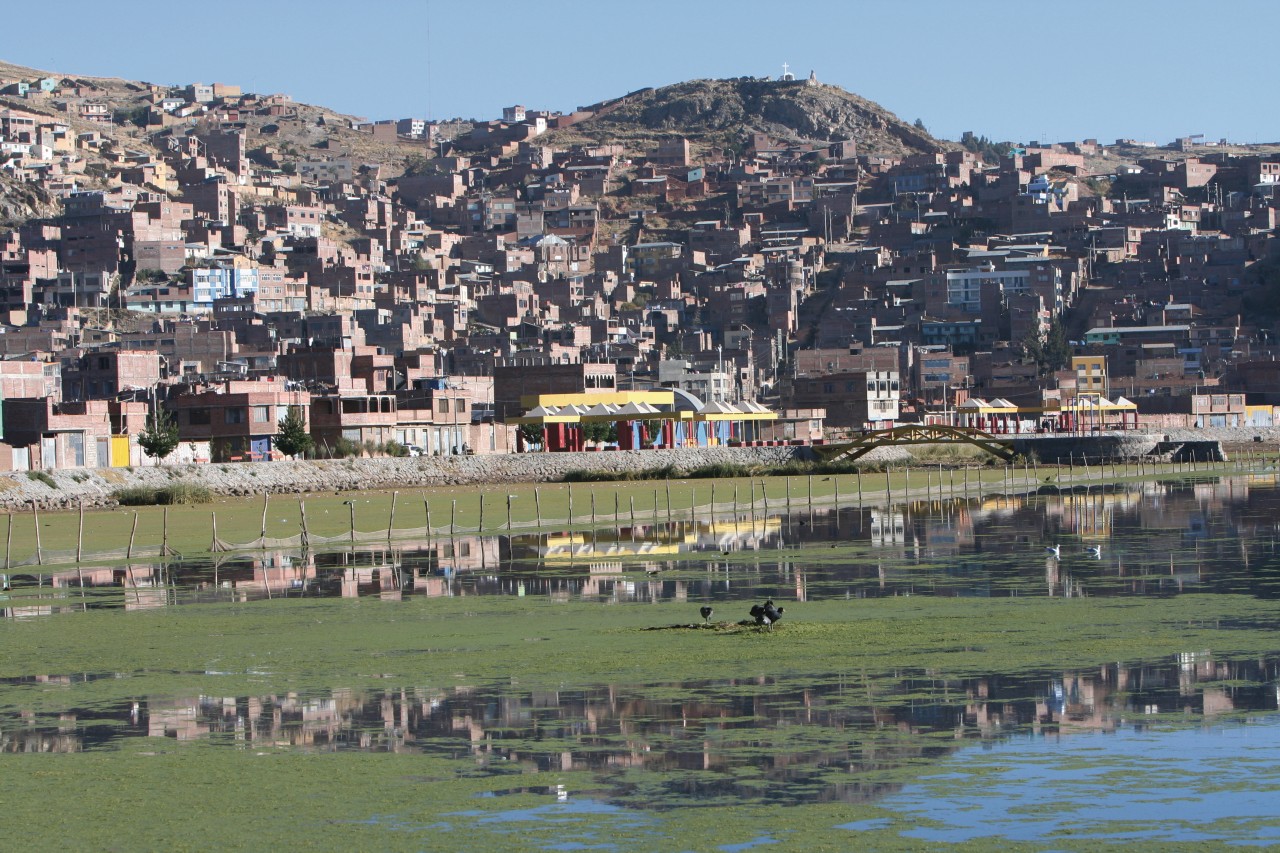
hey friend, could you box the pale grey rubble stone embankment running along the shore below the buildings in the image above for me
[0,428,1280,510]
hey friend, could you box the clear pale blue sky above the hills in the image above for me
[0,0,1280,143]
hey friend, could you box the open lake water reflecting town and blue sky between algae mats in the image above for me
[0,474,1280,844]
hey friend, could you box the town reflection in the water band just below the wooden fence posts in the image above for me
[0,476,1280,616]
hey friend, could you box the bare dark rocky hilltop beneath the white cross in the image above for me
[548,77,951,155]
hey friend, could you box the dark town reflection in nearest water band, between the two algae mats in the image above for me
[0,652,1280,807]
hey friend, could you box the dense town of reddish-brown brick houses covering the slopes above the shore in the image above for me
[0,64,1280,470]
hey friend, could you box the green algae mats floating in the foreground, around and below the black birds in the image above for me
[0,560,1280,849]
